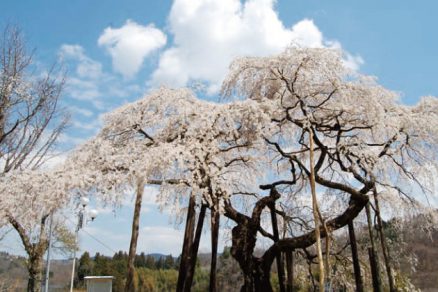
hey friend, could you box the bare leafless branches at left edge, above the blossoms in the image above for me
[0,26,69,173]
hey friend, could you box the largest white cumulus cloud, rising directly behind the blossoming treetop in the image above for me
[149,0,361,93]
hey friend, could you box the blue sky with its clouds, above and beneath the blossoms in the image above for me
[0,0,438,255]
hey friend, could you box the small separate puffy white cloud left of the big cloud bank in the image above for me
[97,20,166,78]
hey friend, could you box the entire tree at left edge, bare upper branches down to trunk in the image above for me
[0,26,68,291]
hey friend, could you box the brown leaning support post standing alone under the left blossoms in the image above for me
[125,178,144,292]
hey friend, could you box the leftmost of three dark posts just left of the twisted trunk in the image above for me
[176,196,196,292]
